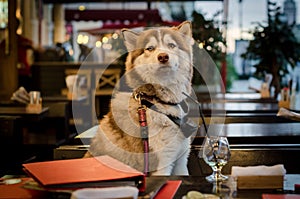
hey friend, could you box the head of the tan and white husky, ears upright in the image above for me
[122,21,193,103]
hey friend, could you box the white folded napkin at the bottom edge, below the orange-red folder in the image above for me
[71,186,139,199]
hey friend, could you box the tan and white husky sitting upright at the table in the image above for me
[84,21,197,175]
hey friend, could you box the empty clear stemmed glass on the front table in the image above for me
[202,136,231,182]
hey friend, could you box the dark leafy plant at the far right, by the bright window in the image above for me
[242,2,300,98]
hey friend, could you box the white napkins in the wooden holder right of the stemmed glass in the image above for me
[231,164,286,176]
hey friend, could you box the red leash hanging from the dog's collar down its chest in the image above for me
[135,94,149,176]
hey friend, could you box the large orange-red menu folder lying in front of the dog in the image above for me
[23,155,145,190]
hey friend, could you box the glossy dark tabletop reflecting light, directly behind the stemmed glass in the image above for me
[196,122,300,144]
